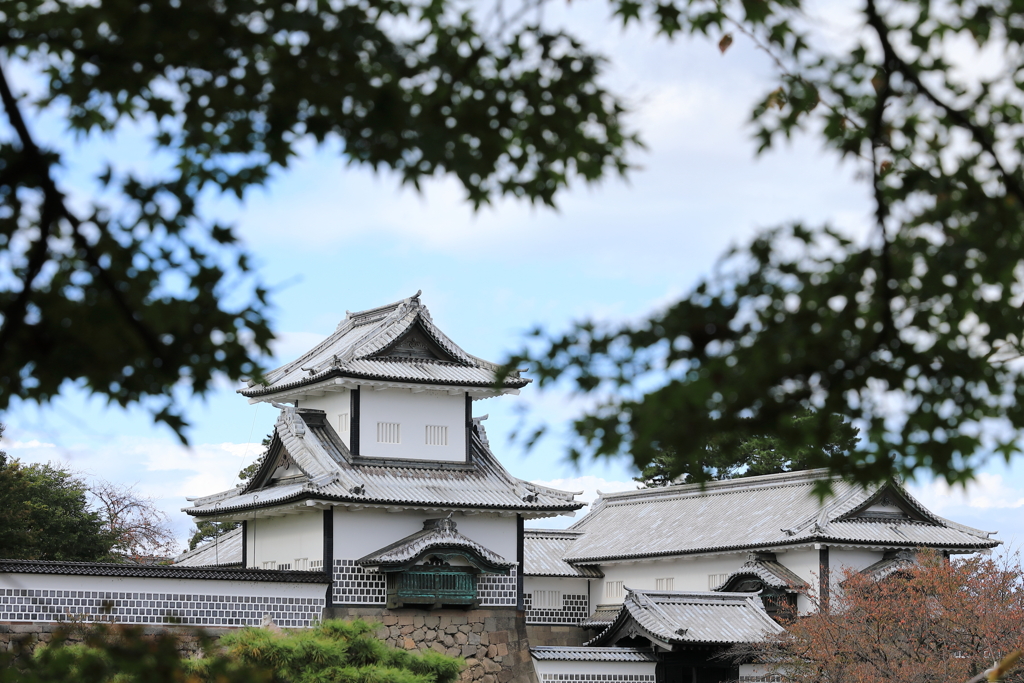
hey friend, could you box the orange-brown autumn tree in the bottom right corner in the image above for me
[746,551,1024,683]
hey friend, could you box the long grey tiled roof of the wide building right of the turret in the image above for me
[565,470,1000,563]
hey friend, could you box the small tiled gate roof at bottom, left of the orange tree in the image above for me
[586,591,783,650]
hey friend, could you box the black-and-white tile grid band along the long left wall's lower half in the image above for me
[0,589,324,628]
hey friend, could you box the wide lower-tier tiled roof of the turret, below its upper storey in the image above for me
[184,407,584,517]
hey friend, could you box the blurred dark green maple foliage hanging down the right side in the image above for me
[507,0,1024,493]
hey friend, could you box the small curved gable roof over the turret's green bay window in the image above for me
[355,515,515,573]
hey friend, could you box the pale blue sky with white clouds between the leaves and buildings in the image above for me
[3,3,1024,557]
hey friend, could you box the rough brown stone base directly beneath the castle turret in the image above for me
[325,606,536,683]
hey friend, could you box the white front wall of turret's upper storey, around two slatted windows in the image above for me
[358,387,466,462]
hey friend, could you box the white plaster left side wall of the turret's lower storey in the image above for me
[246,510,324,569]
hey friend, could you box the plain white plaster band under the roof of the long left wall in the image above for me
[0,573,326,598]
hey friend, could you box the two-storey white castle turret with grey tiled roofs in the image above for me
[186,293,583,613]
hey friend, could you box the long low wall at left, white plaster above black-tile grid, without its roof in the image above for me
[0,574,326,628]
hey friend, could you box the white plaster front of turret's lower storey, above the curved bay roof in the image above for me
[334,506,516,562]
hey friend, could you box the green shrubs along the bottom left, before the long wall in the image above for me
[0,621,463,683]
